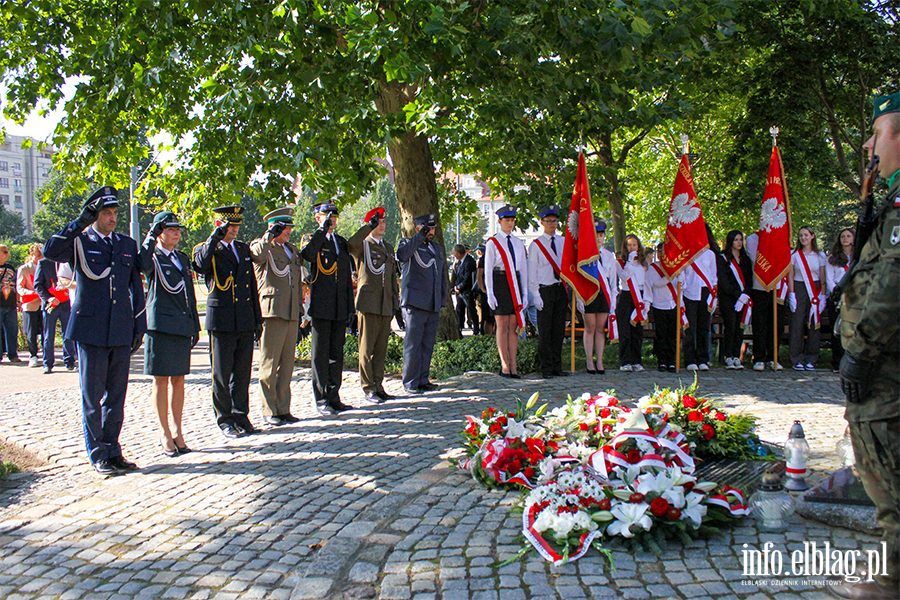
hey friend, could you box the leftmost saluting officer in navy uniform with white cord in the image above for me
[44,186,147,476]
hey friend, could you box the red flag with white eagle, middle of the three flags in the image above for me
[659,153,709,279]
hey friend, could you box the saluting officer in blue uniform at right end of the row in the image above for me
[397,214,447,394]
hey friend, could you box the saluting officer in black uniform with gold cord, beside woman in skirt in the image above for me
[193,206,262,439]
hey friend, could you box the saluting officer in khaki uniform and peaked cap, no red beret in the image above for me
[250,208,303,425]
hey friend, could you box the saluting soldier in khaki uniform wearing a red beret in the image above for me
[347,208,400,404]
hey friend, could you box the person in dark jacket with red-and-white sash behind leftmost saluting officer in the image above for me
[34,258,75,375]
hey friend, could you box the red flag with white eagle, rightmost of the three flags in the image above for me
[753,146,791,291]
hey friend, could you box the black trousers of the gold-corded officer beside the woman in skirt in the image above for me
[209,331,253,428]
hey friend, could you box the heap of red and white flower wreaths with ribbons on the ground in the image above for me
[459,387,761,564]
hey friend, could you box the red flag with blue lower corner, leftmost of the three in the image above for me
[560,152,600,305]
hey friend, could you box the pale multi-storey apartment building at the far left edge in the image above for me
[0,135,55,231]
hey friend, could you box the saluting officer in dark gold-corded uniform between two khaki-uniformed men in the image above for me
[300,201,353,415]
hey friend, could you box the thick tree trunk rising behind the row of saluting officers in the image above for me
[376,80,460,340]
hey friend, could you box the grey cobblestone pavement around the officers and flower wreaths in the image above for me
[0,346,876,600]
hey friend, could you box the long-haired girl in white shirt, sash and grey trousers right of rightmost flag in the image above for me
[788,227,827,371]
